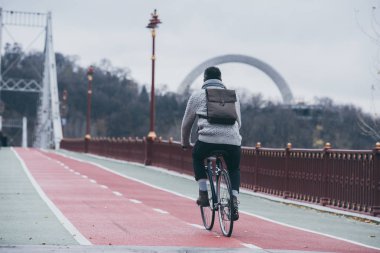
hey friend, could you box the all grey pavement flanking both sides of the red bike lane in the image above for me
[0,148,380,253]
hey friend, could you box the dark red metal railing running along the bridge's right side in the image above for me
[61,138,380,216]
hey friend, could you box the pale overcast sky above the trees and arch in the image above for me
[0,0,380,113]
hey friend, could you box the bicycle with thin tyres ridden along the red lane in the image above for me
[200,151,234,237]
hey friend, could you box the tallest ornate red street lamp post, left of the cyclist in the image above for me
[145,9,161,165]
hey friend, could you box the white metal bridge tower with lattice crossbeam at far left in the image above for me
[0,8,62,149]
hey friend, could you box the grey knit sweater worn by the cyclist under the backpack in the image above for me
[181,79,241,147]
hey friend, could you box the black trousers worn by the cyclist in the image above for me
[193,140,241,191]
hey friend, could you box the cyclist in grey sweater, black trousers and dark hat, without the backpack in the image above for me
[181,67,242,220]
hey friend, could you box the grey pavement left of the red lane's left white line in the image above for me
[0,148,78,245]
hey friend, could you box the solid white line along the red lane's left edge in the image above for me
[11,148,92,245]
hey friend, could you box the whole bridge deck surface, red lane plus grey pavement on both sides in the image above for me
[0,148,380,252]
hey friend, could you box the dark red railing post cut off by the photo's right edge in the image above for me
[371,142,380,216]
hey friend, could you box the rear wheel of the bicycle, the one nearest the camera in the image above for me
[217,168,234,237]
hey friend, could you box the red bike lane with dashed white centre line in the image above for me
[15,148,379,252]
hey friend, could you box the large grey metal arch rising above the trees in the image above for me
[177,54,293,104]
